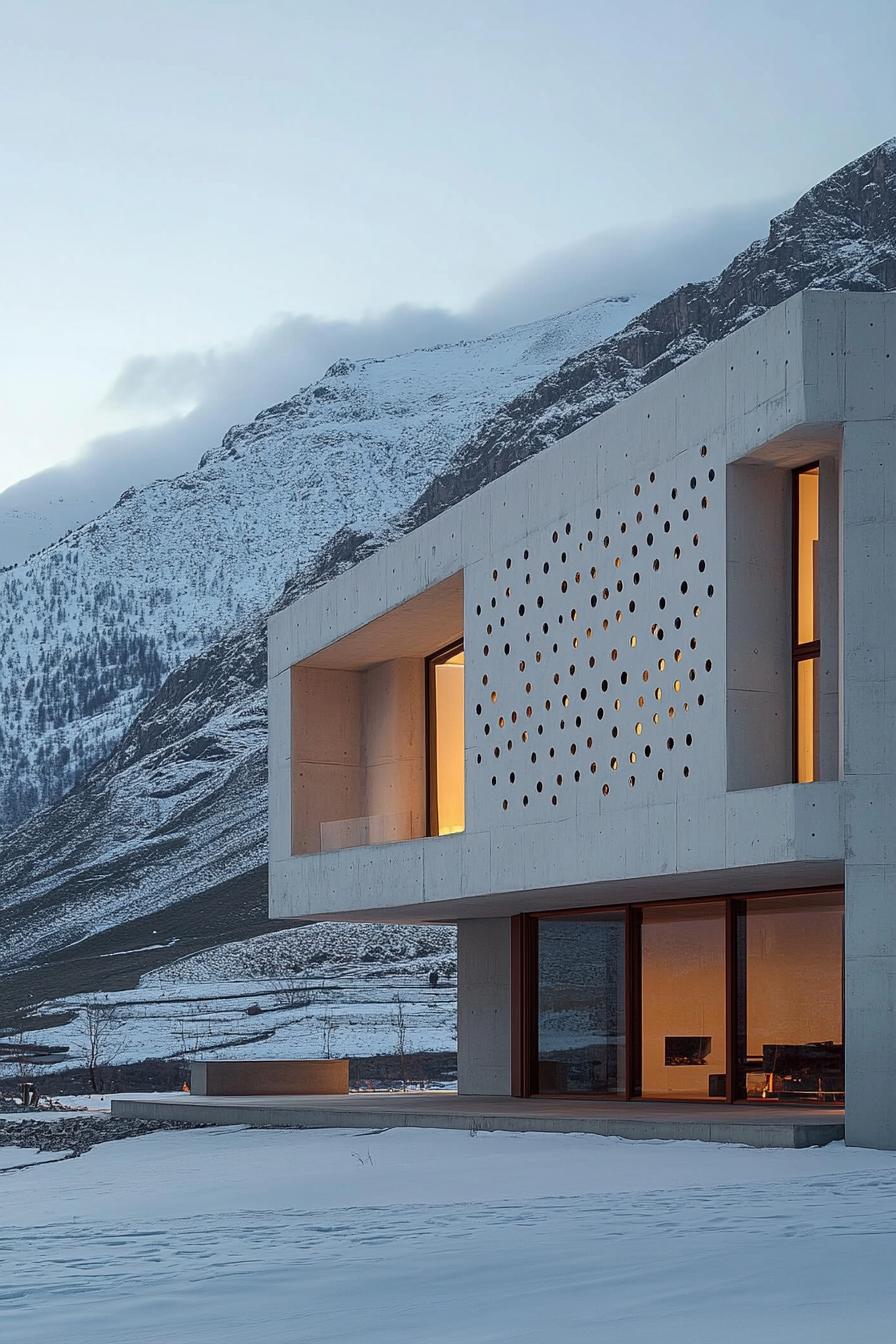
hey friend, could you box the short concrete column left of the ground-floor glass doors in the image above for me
[457,919,510,1097]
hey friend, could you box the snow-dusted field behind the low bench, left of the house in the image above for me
[18,925,457,1073]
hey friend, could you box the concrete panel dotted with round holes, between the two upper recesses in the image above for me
[466,444,724,825]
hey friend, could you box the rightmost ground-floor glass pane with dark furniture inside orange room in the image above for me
[737,892,844,1102]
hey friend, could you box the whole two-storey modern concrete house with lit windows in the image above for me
[269,292,896,1148]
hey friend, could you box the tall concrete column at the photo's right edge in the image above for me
[842,421,896,1148]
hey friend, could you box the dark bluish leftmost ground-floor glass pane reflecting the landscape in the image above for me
[536,913,626,1094]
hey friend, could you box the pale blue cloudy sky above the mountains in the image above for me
[0,0,896,489]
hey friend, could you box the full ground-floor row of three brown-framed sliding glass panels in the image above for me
[519,890,844,1105]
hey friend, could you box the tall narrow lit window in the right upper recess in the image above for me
[793,462,821,784]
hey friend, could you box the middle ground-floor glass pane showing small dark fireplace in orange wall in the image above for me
[641,900,725,1099]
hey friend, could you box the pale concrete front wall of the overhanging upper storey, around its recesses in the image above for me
[270,293,870,919]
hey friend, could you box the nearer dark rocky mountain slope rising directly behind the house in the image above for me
[0,140,896,1032]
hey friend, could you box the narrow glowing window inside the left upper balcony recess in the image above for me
[427,644,463,836]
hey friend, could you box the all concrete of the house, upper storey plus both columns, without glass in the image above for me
[269,292,896,1146]
